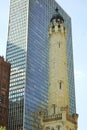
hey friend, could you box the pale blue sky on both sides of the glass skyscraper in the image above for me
[0,0,87,130]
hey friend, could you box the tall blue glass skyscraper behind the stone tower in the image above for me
[6,0,76,130]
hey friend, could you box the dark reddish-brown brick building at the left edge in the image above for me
[0,56,11,129]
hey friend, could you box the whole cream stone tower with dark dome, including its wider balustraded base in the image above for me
[41,9,78,130]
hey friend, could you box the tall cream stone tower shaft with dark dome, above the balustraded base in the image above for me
[48,9,69,114]
